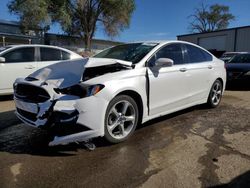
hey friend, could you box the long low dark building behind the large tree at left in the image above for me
[0,20,121,53]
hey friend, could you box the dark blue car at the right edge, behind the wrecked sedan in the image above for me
[226,53,250,80]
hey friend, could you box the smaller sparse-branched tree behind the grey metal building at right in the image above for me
[189,4,235,33]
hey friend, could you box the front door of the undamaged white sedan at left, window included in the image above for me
[0,47,37,94]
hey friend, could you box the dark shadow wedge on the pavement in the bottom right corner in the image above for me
[209,170,250,188]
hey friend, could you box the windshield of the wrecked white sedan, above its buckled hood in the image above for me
[94,43,158,64]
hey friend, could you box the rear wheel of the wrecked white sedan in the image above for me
[207,80,223,108]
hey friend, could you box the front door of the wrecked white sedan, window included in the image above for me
[148,43,189,116]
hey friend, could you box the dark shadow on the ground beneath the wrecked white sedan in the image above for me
[0,105,206,156]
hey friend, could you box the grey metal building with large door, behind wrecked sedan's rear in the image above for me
[177,26,250,56]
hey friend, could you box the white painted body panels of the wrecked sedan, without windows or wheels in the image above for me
[12,41,226,145]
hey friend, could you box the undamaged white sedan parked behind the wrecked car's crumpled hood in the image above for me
[0,45,81,95]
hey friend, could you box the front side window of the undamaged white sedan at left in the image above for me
[3,47,35,63]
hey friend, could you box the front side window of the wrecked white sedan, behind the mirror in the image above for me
[148,44,184,66]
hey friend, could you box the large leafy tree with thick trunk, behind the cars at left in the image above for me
[9,0,135,51]
